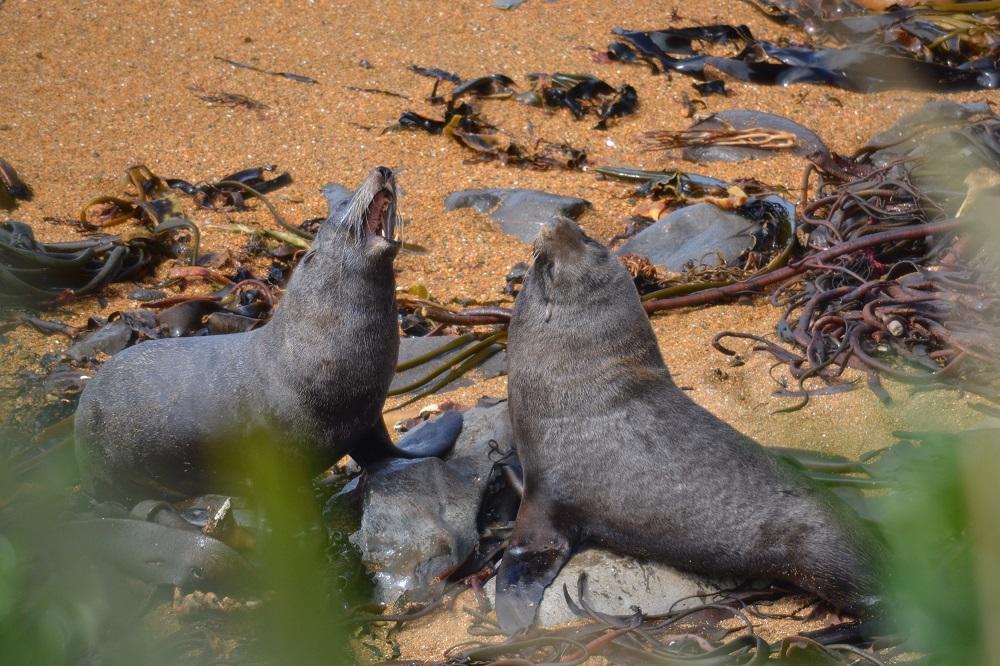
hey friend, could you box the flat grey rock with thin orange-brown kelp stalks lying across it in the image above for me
[683,109,827,162]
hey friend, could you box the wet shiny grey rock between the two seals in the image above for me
[350,403,513,603]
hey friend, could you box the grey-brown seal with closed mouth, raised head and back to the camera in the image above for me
[496,219,880,633]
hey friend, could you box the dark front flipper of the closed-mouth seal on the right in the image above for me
[495,497,575,635]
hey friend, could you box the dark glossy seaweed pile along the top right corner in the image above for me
[602,0,1000,92]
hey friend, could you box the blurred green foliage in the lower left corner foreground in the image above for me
[0,426,353,664]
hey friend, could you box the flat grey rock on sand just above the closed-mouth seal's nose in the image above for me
[444,188,590,243]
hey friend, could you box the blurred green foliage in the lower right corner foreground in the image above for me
[884,429,1000,665]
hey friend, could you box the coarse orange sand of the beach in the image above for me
[0,0,1000,659]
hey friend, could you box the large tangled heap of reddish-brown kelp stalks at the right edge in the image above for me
[715,106,1000,404]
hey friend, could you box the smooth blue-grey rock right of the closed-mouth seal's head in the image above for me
[617,203,755,272]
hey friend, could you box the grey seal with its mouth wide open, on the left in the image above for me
[75,167,441,498]
